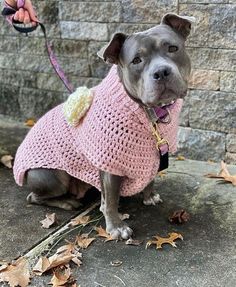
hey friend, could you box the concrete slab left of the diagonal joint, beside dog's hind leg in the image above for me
[0,167,76,262]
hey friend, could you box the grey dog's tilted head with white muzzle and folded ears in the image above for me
[99,14,193,107]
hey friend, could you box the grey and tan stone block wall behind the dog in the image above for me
[0,0,236,163]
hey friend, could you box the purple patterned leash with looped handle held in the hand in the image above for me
[2,3,74,93]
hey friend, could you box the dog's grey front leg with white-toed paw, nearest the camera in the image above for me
[100,171,133,239]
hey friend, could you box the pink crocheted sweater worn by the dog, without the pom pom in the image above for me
[14,66,182,196]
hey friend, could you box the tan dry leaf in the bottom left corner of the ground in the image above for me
[0,257,30,287]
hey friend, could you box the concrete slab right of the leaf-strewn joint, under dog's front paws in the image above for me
[22,159,236,287]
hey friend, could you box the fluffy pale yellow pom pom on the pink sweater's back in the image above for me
[63,87,93,126]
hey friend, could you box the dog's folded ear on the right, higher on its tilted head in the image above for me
[161,13,195,39]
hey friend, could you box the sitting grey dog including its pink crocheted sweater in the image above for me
[14,13,194,239]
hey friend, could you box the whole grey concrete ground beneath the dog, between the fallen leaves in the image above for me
[0,159,236,287]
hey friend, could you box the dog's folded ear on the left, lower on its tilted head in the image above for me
[97,33,128,65]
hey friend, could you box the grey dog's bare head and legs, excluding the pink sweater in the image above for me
[27,14,194,239]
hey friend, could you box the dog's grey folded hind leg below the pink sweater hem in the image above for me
[27,168,80,210]
